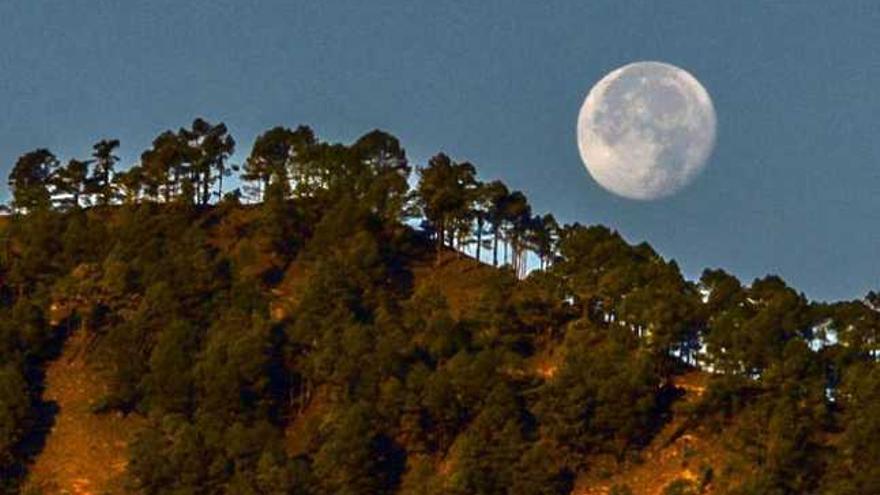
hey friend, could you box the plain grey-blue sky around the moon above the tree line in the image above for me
[0,0,880,299]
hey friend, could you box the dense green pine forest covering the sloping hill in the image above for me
[0,119,880,494]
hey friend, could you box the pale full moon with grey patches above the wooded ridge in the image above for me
[577,62,716,200]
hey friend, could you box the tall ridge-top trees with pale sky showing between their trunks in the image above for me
[9,119,559,276]
